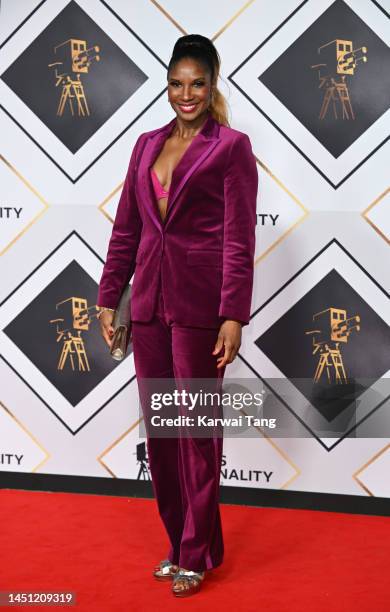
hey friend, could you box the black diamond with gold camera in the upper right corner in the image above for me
[259,0,390,158]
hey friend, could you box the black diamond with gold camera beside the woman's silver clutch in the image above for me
[4,261,131,406]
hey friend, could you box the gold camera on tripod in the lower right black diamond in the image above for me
[305,308,360,384]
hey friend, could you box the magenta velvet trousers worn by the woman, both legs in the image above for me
[132,278,225,571]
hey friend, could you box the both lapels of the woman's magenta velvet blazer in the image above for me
[139,113,220,230]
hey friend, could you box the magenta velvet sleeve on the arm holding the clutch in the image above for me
[97,134,142,309]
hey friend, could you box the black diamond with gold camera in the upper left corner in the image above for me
[1,1,148,153]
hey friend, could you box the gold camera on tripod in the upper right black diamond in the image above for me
[311,38,367,120]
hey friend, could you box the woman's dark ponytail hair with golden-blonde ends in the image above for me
[168,34,229,126]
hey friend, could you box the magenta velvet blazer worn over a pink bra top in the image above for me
[97,112,258,327]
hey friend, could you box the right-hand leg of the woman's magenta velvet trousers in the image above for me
[172,324,225,572]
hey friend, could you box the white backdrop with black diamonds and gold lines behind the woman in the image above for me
[0,0,390,497]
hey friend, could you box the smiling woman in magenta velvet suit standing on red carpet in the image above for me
[97,34,258,596]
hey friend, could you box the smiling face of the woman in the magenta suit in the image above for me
[168,58,211,121]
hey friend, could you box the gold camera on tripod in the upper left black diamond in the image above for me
[48,38,100,117]
